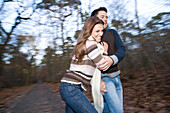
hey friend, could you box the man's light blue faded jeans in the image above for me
[103,76,123,113]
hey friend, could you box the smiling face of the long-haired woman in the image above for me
[91,24,104,42]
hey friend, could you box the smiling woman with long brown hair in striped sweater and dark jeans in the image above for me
[60,16,108,113]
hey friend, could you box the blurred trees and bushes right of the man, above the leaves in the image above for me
[122,12,170,77]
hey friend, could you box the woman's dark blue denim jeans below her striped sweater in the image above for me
[60,82,97,113]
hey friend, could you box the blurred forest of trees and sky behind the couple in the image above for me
[0,0,170,110]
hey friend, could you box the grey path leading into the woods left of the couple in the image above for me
[5,83,65,113]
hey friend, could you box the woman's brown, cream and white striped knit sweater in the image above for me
[61,40,104,90]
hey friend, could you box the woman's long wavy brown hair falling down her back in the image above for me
[73,16,104,62]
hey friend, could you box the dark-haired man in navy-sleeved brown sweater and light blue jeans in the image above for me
[91,7,126,113]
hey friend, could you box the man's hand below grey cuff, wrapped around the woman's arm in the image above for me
[98,55,113,71]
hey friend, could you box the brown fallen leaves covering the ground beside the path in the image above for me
[0,69,170,113]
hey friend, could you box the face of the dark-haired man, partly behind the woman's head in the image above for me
[97,11,107,29]
